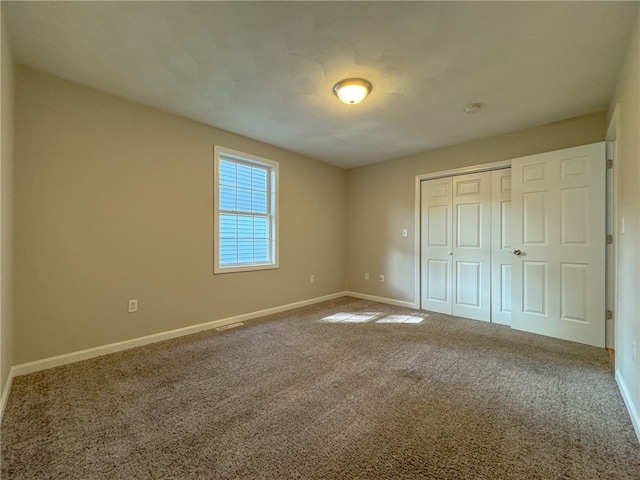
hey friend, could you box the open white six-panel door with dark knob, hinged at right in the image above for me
[511,143,605,347]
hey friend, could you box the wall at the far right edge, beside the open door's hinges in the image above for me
[610,7,640,436]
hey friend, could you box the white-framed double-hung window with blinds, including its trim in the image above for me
[213,146,278,273]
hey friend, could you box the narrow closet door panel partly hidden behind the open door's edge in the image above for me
[491,168,513,325]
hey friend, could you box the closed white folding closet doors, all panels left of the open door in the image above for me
[421,168,511,324]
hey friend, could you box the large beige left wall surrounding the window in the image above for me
[14,66,346,364]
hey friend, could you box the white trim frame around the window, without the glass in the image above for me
[213,145,280,274]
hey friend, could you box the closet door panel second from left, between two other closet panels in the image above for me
[452,172,491,322]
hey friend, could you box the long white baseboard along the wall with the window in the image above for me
[10,292,347,378]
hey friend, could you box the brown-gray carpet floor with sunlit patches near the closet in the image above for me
[0,297,640,480]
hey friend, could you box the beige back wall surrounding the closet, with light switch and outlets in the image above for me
[346,113,606,303]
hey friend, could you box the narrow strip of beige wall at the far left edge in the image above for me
[0,18,14,398]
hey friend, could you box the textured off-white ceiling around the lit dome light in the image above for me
[2,1,638,168]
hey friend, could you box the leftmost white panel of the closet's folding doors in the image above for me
[420,177,453,314]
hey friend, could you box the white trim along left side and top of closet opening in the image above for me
[413,160,511,309]
